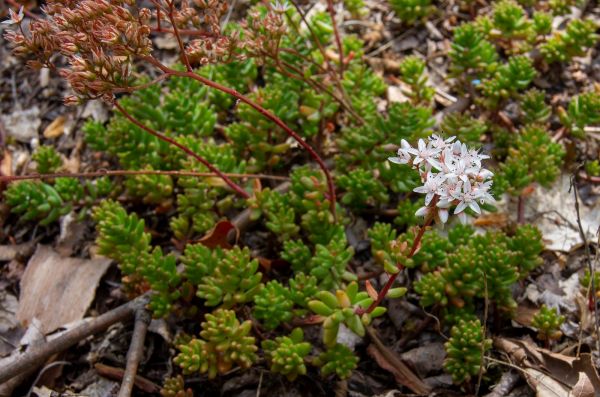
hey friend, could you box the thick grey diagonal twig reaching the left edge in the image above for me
[0,295,148,383]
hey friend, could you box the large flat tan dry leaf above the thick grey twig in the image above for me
[17,245,111,334]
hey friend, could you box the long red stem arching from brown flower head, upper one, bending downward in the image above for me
[144,56,336,218]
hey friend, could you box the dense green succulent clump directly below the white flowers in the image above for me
[414,225,543,312]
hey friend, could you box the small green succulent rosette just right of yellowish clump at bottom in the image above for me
[261,328,312,381]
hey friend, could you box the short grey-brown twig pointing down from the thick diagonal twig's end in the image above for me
[118,308,152,397]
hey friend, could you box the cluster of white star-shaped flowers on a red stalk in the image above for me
[389,135,495,223]
